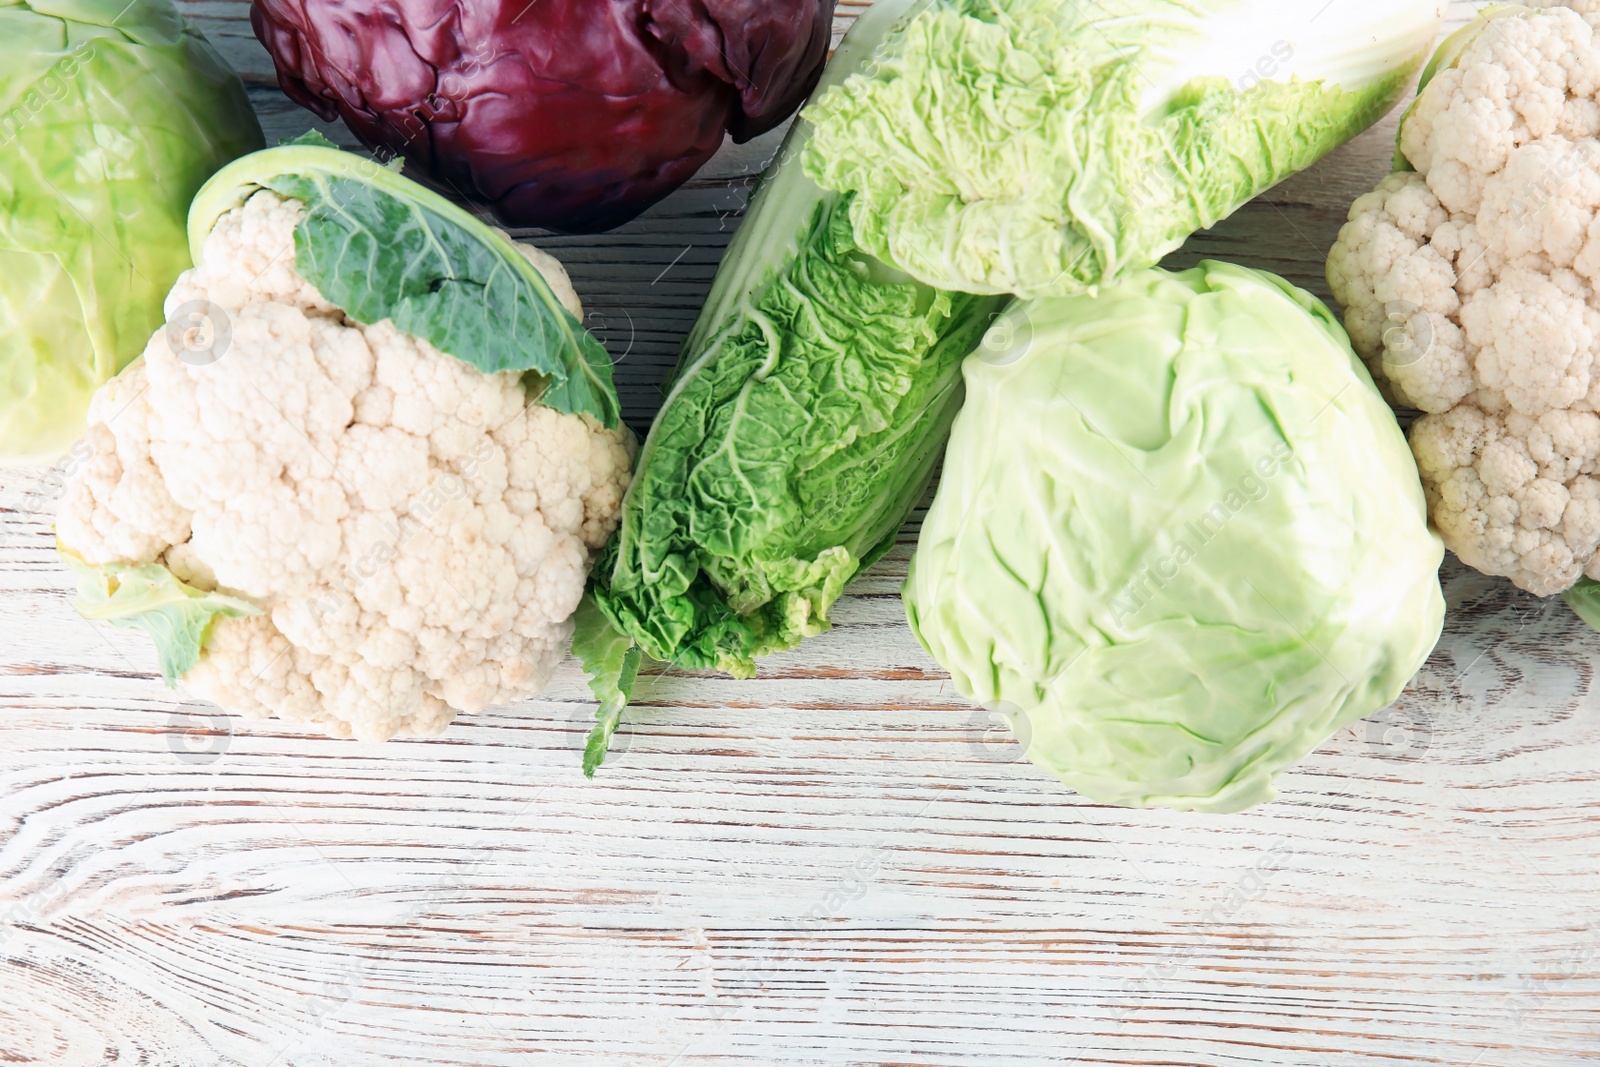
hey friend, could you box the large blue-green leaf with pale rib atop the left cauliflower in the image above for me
[189,142,621,427]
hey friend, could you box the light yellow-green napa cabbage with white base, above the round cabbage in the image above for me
[805,0,1438,296]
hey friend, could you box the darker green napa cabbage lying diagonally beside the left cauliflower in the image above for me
[594,0,1005,677]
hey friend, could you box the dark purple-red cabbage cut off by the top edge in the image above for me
[250,0,835,232]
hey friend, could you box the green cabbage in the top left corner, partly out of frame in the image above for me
[0,0,261,464]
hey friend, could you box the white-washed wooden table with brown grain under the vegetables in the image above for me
[0,0,1600,1067]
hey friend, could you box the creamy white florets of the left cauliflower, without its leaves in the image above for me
[56,190,634,739]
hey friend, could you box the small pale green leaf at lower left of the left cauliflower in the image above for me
[58,549,261,686]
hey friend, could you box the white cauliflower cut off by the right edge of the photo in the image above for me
[1328,0,1600,597]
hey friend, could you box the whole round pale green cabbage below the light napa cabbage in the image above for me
[904,262,1445,811]
